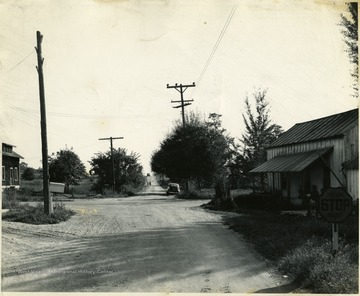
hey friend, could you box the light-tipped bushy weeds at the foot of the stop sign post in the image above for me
[278,238,358,294]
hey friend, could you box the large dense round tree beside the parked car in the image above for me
[151,113,230,199]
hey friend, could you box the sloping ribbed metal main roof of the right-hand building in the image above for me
[267,109,359,148]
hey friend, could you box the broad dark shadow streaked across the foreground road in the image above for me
[2,223,278,293]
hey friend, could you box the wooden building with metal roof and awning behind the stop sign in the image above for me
[251,109,359,204]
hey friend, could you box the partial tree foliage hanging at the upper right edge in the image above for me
[340,2,359,97]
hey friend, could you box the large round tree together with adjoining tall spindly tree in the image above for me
[151,90,282,199]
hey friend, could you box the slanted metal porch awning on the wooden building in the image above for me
[250,147,333,173]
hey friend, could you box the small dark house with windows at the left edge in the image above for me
[1,143,23,188]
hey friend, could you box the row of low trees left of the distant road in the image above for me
[21,148,144,193]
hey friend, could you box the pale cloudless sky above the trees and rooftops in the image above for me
[0,0,358,173]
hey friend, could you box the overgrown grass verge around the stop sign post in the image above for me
[221,210,359,294]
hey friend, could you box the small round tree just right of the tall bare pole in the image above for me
[49,148,86,192]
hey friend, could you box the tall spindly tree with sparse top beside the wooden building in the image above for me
[231,90,283,186]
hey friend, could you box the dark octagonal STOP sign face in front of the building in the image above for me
[319,187,352,223]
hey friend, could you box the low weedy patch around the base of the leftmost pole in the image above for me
[3,203,75,225]
